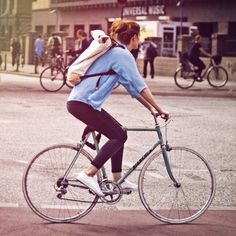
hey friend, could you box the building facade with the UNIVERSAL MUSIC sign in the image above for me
[31,0,236,56]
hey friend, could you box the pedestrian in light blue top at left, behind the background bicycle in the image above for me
[34,35,44,74]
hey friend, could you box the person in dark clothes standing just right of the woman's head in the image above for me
[142,38,157,79]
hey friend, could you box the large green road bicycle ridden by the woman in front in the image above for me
[22,117,216,224]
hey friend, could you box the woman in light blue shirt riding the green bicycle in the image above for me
[67,20,169,196]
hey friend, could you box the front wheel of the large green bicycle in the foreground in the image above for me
[139,147,216,224]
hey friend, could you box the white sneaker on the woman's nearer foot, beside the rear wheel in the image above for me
[76,171,104,197]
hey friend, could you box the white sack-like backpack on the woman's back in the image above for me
[68,30,112,84]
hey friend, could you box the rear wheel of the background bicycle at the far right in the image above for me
[174,67,195,89]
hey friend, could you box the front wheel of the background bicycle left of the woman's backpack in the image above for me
[39,66,65,92]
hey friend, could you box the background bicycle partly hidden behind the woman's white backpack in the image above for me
[39,55,74,92]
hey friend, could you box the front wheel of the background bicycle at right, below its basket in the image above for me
[207,66,229,88]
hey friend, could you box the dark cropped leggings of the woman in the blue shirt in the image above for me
[67,101,127,173]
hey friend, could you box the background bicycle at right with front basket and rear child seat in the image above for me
[174,52,229,89]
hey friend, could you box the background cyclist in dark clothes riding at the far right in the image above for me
[189,34,211,82]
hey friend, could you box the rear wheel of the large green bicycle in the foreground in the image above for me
[22,144,101,222]
